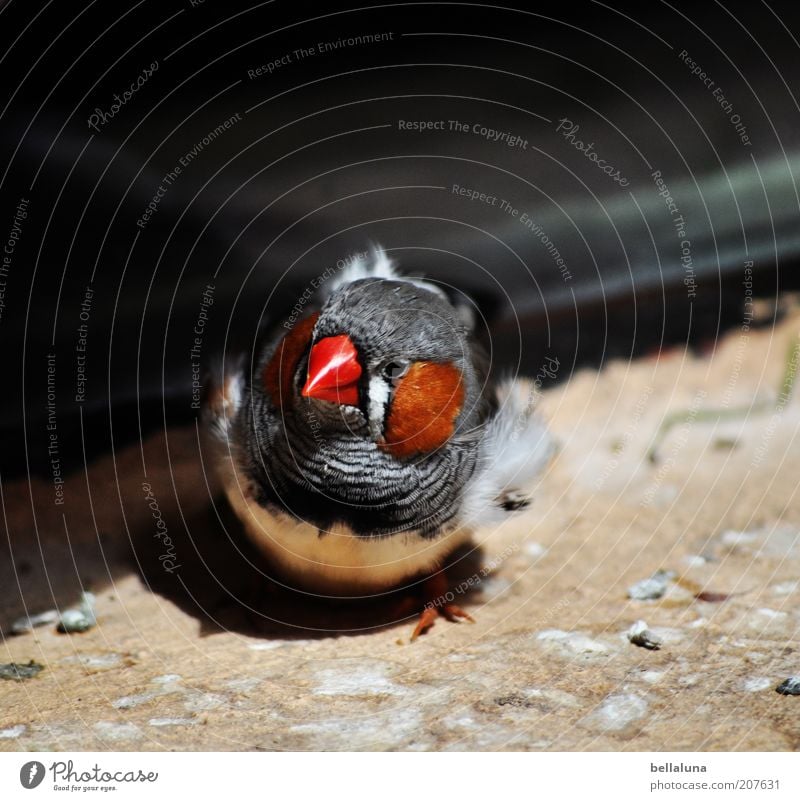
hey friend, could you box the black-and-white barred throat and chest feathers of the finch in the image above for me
[239,390,478,538]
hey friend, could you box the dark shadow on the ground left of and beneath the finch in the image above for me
[0,428,481,639]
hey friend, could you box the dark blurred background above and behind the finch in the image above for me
[0,0,800,481]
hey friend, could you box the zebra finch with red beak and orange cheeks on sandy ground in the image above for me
[203,247,553,640]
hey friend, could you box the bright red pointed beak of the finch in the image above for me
[300,334,361,406]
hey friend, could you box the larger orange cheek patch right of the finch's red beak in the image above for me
[382,362,464,459]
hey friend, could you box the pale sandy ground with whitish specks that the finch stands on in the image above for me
[0,308,800,750]
